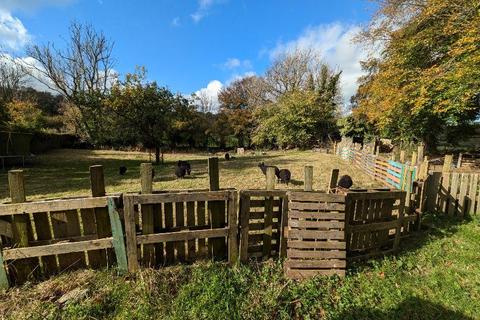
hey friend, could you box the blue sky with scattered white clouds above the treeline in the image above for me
[0,0,373,107]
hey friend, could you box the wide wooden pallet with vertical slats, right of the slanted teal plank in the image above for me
[123,190,238,272]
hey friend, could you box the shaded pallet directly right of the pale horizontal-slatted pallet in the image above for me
[345,191,404,260]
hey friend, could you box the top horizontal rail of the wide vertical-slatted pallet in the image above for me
[133,191,229,204]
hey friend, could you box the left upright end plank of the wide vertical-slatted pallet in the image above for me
[123,195,138,272]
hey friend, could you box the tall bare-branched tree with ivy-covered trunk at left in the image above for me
[22,23,116,143]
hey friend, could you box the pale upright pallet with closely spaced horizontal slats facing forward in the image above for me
[284,192,347,279]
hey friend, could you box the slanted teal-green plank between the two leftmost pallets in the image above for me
[108,198,128,274]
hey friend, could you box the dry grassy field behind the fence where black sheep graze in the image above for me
[0,150,380,202]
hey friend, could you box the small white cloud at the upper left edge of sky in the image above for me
[0,8,30,50]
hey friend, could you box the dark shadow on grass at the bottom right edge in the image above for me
[335,297,473,320]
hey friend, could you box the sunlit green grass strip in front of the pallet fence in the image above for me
[0,215,480,320]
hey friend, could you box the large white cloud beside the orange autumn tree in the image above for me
[269,23,368,107]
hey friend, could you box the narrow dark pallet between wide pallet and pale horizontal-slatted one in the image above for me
[239,190,287,262]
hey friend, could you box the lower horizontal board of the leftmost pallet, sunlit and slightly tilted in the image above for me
[3,237,112,260]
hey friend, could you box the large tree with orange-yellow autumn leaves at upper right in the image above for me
[354,0,480,149]
